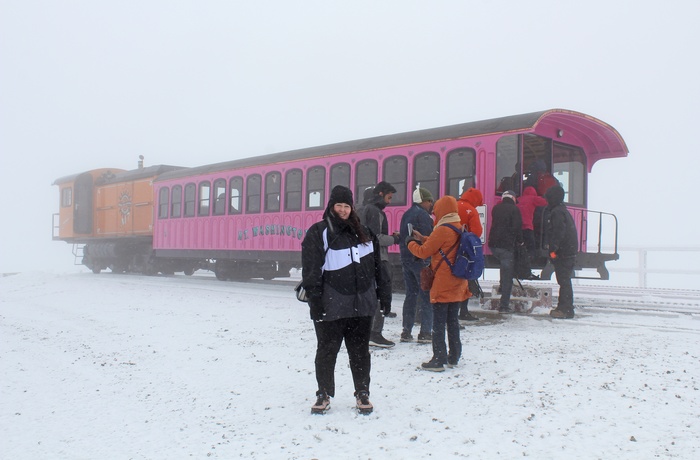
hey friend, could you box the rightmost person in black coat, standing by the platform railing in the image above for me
[544,185,578,319]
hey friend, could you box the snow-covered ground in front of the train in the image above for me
[0,273,700,459]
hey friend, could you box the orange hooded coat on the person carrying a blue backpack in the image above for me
[408,195,471,303]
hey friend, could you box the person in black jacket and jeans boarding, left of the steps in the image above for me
[489,190,524,313]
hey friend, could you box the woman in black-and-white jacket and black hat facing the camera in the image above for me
[301,185,391,413]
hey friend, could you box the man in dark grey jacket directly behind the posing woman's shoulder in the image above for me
[360,181,399,348]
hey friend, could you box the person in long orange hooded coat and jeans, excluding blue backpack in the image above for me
[406,195,471,372]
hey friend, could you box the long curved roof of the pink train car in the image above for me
[149,109,628,181]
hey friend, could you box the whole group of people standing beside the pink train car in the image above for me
[302,181,577,414]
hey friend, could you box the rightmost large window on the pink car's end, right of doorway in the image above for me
[556,143,588,207]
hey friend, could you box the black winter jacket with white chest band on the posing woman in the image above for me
[301,214,391,321]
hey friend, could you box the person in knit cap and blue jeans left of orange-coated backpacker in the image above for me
[399,188,433,343]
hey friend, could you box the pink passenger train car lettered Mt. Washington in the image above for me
[152,109,628,279]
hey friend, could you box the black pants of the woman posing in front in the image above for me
[314,316,372,396]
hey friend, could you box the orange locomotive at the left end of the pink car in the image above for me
[53,161,196,274]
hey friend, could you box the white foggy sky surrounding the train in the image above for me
[0,0,700,272]
